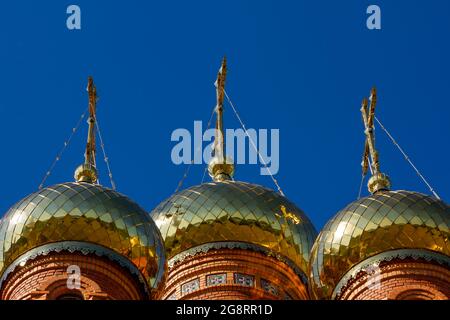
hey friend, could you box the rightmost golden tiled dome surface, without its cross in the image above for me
[309,191,450,299]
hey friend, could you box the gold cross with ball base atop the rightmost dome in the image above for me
[361,87,391,193]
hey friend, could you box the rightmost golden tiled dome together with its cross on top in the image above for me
[309,90,450,299]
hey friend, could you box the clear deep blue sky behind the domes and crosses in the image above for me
[0,0,450,229]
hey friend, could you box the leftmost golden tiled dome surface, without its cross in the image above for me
[0,182,166,289]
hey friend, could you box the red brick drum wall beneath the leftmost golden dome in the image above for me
[0,253,147,300]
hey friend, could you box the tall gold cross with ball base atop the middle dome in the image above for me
[208,57,234,182]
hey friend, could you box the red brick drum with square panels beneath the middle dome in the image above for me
[162,249,309,300]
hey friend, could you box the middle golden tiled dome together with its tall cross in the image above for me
[151,58,317,281]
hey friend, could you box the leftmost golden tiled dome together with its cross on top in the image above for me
[0,77,167,295]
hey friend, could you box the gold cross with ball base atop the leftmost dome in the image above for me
[74,77,97,183]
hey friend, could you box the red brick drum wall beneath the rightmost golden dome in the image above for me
[338,259,450,300]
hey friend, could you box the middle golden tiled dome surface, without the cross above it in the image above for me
[152,180,317,274]
